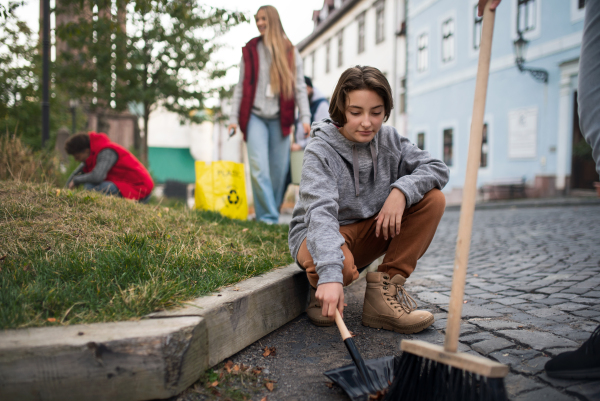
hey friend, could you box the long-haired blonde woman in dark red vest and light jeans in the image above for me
[228,6,310,224]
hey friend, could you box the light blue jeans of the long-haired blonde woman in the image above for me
[246,114,290,224]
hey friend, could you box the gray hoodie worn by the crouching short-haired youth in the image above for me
[288,119,449,284]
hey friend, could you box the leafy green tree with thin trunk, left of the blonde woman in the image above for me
[57,0,248,162]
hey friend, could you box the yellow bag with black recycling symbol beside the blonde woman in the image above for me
[195,161,248,220]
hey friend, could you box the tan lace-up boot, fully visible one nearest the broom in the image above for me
[362,272,433,334]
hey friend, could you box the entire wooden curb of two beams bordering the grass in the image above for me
[0,264,309,401]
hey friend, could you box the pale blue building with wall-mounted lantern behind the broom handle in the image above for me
[407,0,598,202]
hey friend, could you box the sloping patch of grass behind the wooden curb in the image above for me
[0,181,292,329]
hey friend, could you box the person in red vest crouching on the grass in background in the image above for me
[65,132,154,202]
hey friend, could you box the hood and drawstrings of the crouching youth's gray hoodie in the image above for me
[310,118,379,196]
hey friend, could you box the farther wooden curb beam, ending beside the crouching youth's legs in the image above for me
[149,264,309,366]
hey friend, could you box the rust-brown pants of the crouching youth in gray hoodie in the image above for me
[296,189,446,288]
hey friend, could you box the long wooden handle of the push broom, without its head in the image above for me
[444,0,496,352]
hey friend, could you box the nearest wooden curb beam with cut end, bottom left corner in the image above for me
[0,317,208,401]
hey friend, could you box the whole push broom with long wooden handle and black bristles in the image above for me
[385,1,508,401]
